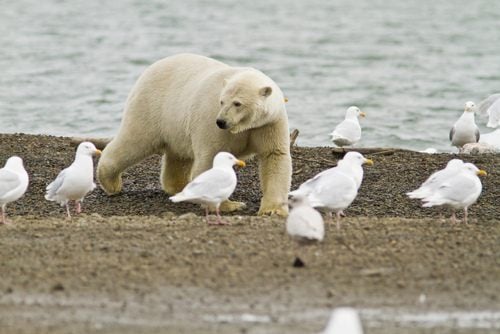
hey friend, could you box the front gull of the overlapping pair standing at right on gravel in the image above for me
[422,163,487,224]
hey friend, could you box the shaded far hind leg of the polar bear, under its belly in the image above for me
[160,153,193,195]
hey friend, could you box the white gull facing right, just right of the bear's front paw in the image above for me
[289,152,373,229]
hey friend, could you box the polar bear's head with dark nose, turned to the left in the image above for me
[216,70,283,134]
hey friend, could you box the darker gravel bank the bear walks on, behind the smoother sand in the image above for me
[0,134,500,222]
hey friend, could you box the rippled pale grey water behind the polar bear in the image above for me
[0,0,500,151]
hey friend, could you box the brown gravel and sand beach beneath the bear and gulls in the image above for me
[0,135,500,333]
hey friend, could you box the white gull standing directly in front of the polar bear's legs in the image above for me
[170,152,245,225]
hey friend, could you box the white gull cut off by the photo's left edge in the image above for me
[0,156,29,224]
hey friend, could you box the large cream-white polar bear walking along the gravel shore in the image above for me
[97,54,292,216]
